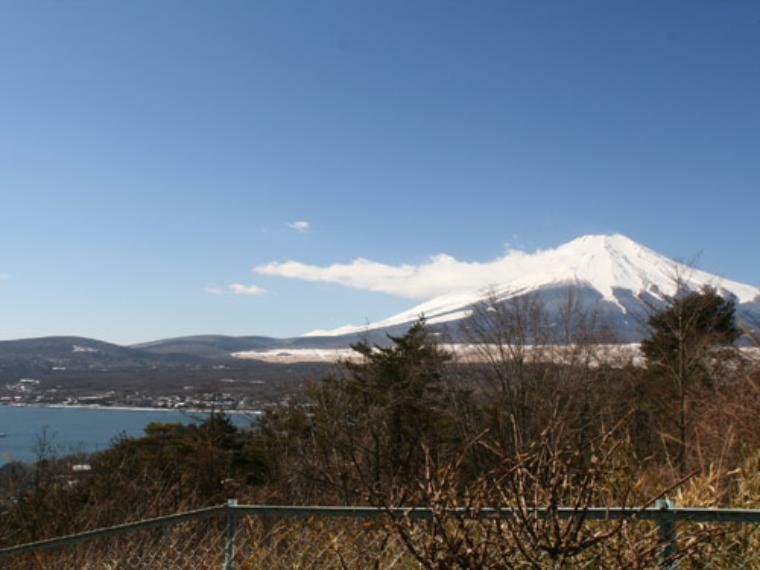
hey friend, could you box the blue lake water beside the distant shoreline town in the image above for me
[0,406,255,465]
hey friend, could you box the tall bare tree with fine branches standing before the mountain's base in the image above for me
[463,288,613,452]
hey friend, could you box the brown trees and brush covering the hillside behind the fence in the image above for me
[0,291,760,568]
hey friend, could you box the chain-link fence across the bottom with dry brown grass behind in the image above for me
[0,501,760,570]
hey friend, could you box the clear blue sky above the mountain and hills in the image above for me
[0,0,760,343]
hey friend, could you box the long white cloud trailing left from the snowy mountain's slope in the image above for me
[255,251,527,299]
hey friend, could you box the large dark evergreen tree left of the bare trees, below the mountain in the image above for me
[257,320,457,504]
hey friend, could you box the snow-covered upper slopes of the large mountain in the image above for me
[305,234,760,340]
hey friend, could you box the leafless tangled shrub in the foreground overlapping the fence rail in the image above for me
[378,414,686,569]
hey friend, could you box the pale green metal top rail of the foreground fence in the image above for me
[0,501,760,558]
